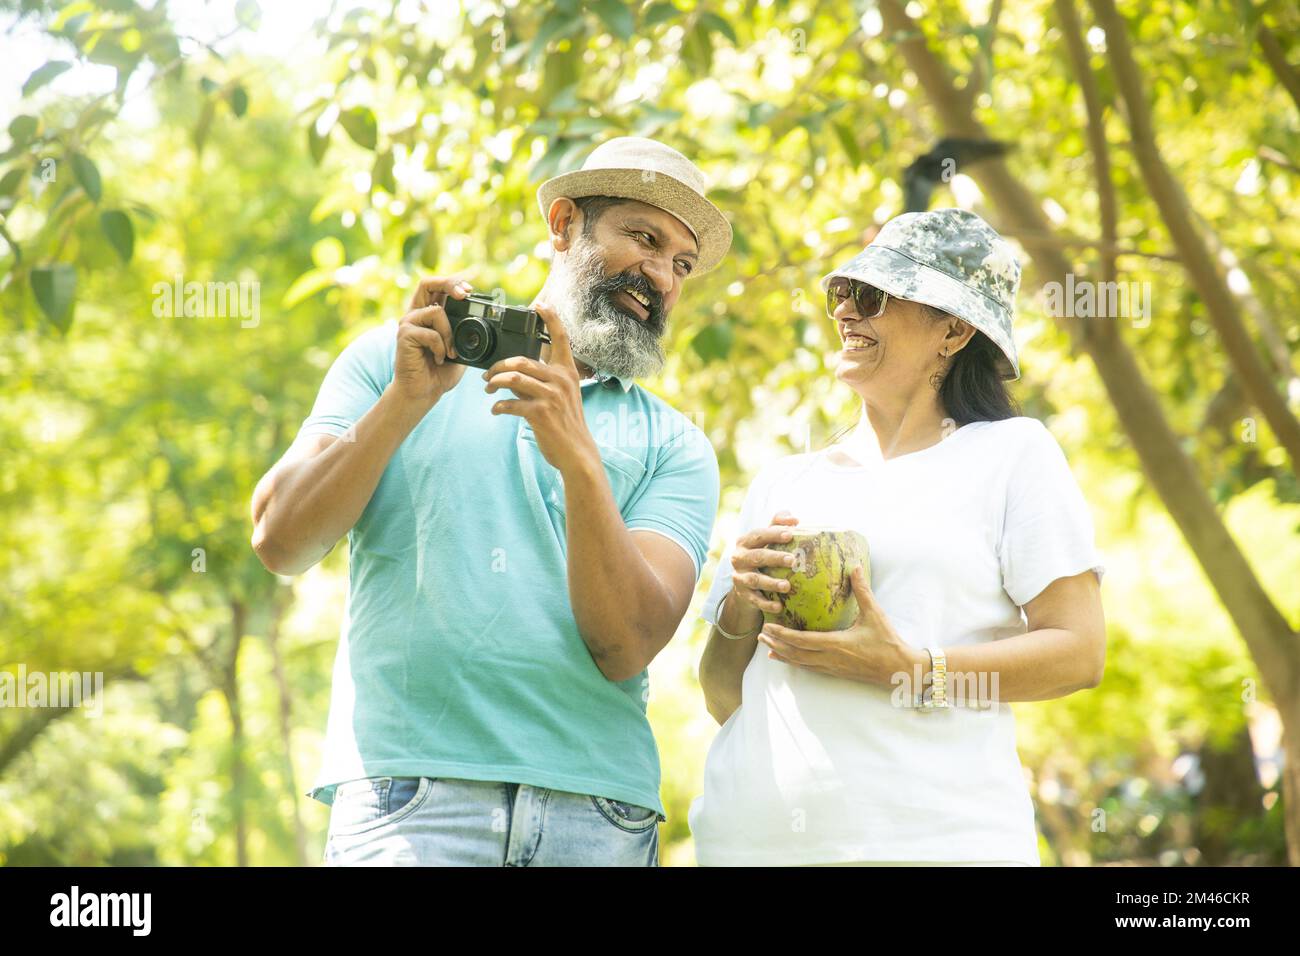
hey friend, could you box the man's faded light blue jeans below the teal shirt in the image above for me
[325,777,659,866]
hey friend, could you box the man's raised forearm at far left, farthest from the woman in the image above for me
[252,388,428,574]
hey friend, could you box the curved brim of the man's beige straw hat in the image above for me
[537,169,732,276]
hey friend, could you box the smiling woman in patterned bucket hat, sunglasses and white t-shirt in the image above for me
[689,209,1105,866]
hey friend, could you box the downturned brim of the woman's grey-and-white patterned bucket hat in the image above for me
[822,246,1021,381]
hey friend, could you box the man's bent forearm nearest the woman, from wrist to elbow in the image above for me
[564,455,679,680]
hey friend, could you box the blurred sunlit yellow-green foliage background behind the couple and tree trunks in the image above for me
[0,0,1300,865]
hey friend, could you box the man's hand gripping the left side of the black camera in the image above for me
[393,276,472,411]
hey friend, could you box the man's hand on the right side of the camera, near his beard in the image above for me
[484,303,601,475]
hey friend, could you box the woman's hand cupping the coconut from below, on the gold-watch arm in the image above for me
[758,564,930,687]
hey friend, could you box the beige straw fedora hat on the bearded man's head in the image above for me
[537,137,732,276]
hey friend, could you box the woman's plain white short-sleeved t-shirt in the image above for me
[689,418,1104,866]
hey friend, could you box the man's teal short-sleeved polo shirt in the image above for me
[300,320,719,817]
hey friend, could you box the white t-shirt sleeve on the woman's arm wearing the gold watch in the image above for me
[998,421,1105,607]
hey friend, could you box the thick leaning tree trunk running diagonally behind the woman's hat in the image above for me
[879,0,1300,862]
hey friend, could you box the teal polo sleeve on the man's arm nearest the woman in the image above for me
[623,427,720,584]
